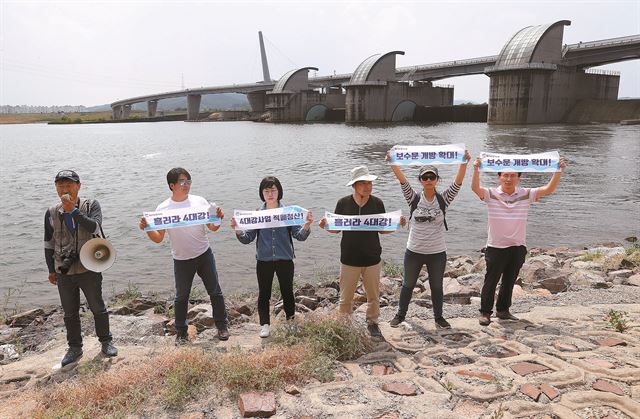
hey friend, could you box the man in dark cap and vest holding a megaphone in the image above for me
[44,170,118,367]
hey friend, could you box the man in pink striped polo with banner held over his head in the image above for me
[471,152,567,326]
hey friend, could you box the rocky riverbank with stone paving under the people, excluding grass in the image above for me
[0,243,640,418]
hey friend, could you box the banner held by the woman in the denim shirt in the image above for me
[233,205,309,230]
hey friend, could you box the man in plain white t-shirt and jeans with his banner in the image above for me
[139,167,229,345]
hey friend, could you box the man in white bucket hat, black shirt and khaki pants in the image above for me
[319,166,405,337]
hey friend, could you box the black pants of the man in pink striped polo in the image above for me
[480,246,527,315]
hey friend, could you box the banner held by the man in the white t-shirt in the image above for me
[142,202,222,231]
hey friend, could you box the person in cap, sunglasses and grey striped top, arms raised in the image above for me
[386,146,471,329]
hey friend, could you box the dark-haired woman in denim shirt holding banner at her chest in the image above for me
[231,176,313,338]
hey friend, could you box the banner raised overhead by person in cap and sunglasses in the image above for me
[389,144,465,166]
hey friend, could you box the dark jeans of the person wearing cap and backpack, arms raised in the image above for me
[398,249,447,319]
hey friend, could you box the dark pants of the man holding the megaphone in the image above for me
[56,271,112,348]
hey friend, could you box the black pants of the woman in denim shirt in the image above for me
[256,260,296,325]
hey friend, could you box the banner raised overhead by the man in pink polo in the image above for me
[479,151,560,173]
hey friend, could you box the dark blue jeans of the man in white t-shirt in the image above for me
[173,248,227,329]
